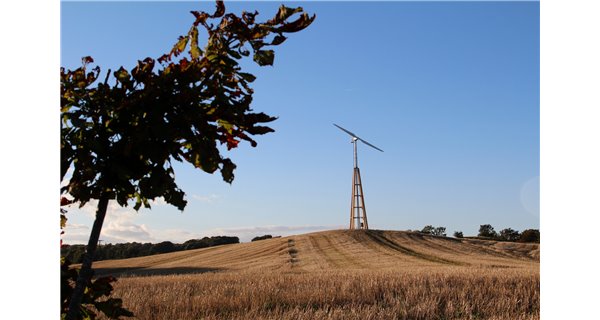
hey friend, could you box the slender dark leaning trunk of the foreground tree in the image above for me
[66,194,108,320]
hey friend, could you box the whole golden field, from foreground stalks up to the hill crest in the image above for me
[95,230,540,319]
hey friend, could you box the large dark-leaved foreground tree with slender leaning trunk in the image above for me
[60,1,315,319]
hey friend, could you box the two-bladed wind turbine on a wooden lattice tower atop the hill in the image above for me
[333,123,383,230]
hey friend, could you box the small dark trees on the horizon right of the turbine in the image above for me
[416,224,540,243]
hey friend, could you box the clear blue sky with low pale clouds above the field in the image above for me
[60,2,540,243]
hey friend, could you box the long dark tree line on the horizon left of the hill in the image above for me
[60,236,240,263]
